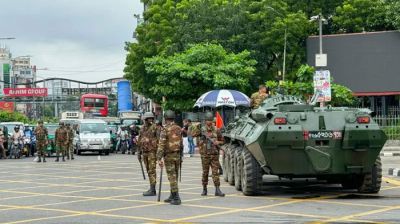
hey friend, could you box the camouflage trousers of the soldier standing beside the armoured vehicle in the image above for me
[201,155,220,187]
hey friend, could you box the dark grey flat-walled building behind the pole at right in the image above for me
[307,31,400,115]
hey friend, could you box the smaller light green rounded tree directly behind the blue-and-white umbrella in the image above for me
[145,44,256,110]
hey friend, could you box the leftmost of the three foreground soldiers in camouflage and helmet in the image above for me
[138,112,157,196]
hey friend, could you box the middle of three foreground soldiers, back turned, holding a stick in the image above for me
[157,110,183,205]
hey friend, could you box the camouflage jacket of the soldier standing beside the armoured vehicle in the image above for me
[199,125,224,155]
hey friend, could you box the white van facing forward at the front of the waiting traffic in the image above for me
[74,119,111,155]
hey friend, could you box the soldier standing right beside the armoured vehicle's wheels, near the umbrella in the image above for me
[199,112,225,197]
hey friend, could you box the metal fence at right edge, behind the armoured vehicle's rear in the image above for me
[374,114,400,140]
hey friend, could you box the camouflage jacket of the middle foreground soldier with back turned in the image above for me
[157,122,183,160]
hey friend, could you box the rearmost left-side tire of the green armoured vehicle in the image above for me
[241,148,262,196]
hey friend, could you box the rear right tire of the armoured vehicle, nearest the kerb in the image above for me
[358,156,382,194]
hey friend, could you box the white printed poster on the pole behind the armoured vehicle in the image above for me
[314,70,332,102]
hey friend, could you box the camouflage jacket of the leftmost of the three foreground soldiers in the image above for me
[138,124,157,152]
